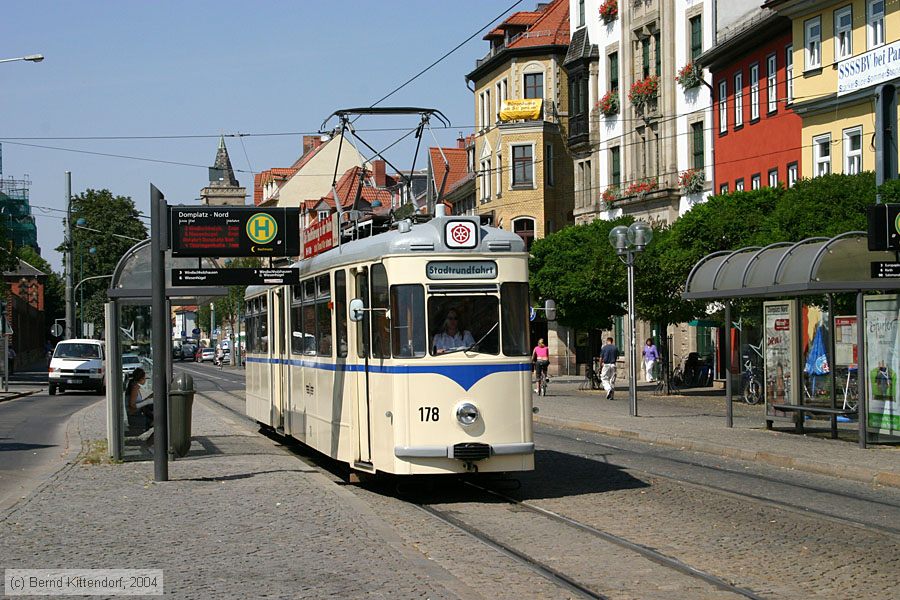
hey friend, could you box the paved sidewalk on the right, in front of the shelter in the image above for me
[534,377,900,487]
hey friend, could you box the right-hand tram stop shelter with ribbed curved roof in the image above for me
[682,231,900,448]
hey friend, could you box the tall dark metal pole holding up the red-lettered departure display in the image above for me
[150,184,171,481]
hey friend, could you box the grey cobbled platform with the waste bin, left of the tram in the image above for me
[0,396,478,599]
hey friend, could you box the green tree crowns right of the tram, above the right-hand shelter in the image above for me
[530,173,884,330]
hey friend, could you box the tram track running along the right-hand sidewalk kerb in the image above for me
[535,431,900,536]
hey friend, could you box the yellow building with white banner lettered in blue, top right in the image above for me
[765,0,900,177]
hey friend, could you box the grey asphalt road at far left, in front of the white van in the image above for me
[0,391,103,510]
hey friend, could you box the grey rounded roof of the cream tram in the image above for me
[246,216,525,295]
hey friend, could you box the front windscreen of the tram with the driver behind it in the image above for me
[428,294,500,355]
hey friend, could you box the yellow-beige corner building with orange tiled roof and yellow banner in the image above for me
[466,0,574,247]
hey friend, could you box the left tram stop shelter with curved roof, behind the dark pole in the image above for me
[105,238,227,460]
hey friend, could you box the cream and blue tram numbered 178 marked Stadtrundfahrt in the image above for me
[245,217,534,475]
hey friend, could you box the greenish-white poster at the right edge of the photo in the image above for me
[865,295,900,435]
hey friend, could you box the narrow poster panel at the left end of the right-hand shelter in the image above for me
[763,301,797,417]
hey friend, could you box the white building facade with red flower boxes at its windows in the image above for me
[566,0,713,229]
